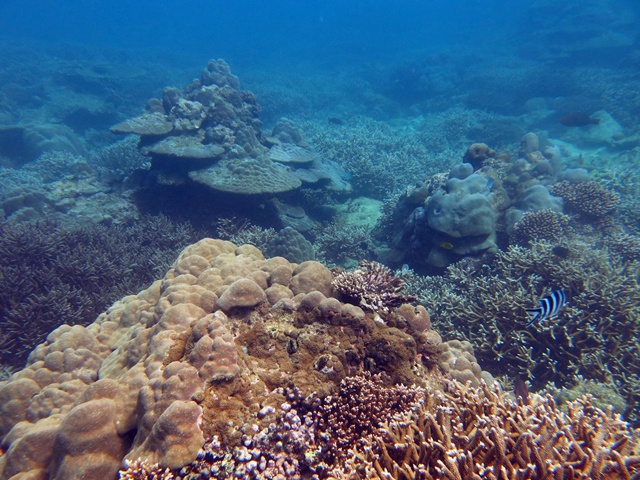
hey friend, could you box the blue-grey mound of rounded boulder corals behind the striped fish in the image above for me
[377,132,620,273]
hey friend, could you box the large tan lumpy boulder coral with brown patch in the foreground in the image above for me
[0,239,450,480]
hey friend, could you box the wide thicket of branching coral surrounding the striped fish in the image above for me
[412,239,640,422]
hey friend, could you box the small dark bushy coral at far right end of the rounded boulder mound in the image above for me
[552,180,620,218]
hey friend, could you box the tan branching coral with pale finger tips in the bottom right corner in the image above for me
[338,383,640,480]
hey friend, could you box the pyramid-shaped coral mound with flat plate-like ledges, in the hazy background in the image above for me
[112,60,350,195]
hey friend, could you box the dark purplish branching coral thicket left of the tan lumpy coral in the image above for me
[0,216,203,367]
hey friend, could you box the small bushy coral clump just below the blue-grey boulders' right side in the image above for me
[511,209,569,246]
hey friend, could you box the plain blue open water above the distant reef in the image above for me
[0,0,527,69]
